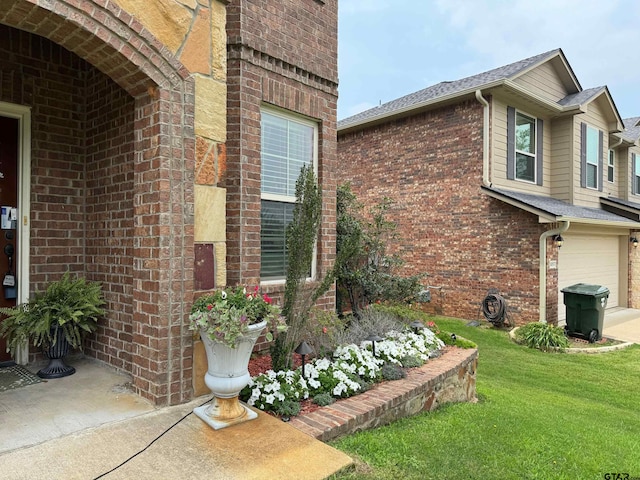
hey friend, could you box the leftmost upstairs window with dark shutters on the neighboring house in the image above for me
[507,107,543,185]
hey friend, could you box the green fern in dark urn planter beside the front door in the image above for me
[0,272,105,378]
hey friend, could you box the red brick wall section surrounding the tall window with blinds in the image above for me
[223,0,337,308]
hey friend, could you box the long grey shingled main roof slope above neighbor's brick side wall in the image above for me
[338,48,562,130]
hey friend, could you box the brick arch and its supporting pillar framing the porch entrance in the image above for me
[0,0,195,405]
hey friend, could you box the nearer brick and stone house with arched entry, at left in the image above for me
[0,0,337,405]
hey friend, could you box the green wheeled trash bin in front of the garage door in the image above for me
[562,283,609,343]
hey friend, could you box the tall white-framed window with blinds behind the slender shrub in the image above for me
[260,110,317,280]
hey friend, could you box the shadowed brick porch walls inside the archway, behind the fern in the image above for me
[0,26,134,360]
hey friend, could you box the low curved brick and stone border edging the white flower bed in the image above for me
[290,347,478,442]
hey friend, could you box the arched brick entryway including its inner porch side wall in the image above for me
[0,0,195,405]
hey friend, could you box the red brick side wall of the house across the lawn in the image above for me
[337,100,552,322]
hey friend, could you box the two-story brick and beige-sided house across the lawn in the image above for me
[338,49,640,323]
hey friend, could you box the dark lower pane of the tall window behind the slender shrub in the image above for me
[260,200,294,280]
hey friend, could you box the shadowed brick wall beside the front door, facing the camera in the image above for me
[0,26,88,290]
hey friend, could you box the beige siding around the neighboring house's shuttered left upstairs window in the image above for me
[491,98,551,195]
